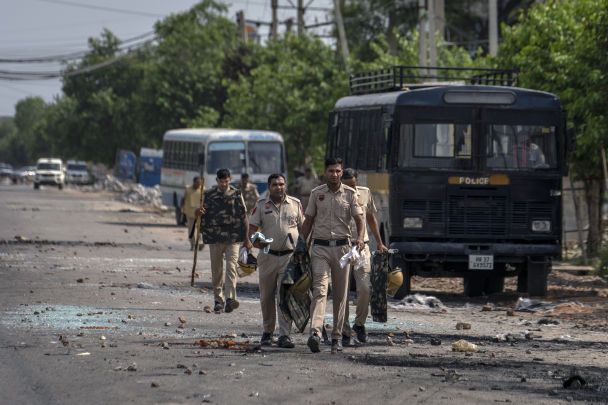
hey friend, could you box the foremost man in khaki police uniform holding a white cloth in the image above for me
[302,158,365,353]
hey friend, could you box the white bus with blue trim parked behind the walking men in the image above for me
[160,128,287,224]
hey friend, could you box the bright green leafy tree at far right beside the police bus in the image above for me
[497,0,608,256]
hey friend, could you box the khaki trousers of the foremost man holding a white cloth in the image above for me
[310,245,350,339]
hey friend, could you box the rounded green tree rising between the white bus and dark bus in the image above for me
[225,35,348,169]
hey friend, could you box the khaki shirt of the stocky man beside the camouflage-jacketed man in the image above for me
[249,196,304,251]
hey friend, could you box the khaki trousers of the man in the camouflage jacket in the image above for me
[209,242,241,305]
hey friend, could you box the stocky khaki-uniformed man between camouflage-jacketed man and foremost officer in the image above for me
[247,174,304,349]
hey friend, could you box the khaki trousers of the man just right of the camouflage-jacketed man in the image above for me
[258,251,292,336]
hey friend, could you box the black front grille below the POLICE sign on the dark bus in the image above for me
[448,195,507,236]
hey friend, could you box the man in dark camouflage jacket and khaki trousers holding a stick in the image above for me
[198,169,251,313]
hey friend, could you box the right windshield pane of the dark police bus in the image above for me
[486,125,557,170]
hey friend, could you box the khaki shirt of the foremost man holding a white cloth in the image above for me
[306,184,363,240]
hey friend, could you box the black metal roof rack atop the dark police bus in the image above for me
[350,66,518,95]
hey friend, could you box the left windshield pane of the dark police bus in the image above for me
[398,123,472,169]
